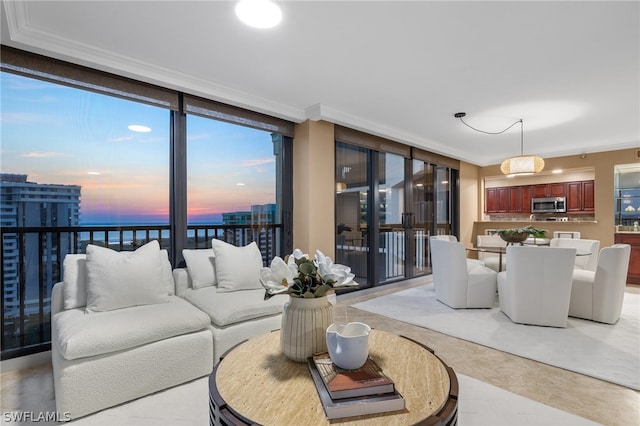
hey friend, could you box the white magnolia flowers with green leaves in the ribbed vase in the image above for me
[260,249,358,300]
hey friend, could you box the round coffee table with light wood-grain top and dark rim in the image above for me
[209,330,458,426]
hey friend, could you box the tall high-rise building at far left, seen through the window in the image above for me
[0,173,81,318]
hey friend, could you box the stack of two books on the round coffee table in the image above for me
[308,353,405,419]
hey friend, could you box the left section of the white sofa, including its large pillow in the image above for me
[51,241,213,419]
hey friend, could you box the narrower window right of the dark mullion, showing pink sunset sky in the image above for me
[187,115,281,264]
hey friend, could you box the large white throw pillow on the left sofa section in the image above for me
[86,240,169,312]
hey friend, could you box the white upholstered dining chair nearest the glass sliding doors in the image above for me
[429,237,496,309]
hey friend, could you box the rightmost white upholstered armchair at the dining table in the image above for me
[569,244,631,324]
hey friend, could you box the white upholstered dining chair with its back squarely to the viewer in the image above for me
[498,246,576,327]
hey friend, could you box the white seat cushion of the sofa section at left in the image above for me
[52,296,210,360]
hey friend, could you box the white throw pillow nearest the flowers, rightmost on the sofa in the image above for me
[212,239,262,293]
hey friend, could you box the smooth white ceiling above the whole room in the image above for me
[0,0,640,166]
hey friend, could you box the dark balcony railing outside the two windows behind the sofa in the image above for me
[0,224,282,359]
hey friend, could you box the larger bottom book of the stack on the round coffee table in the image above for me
[307,358,405,419]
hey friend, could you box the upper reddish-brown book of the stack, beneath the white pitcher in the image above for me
[312,353,394,399]
